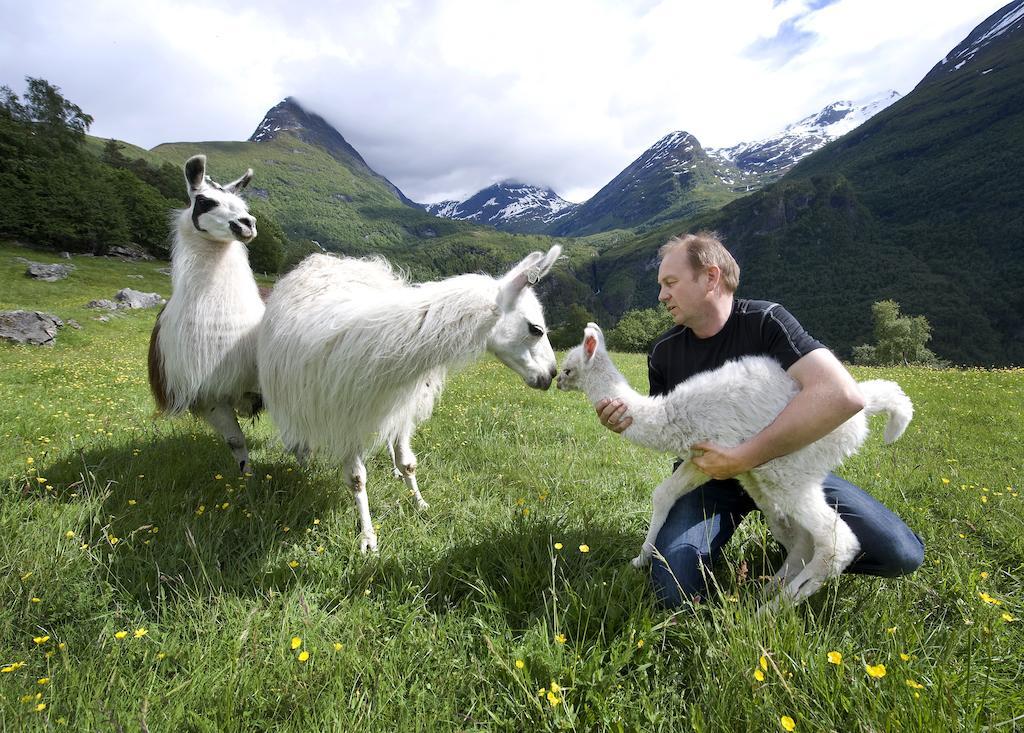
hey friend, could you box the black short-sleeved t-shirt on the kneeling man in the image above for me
[647,299,824,395]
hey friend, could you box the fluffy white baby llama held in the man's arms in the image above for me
[558,324,913,610]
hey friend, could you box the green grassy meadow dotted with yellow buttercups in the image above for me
[0,246,1024,731]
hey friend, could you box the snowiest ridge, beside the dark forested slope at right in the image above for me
[708,90,899,187]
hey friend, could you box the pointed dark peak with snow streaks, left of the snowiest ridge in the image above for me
[547,130,743,236]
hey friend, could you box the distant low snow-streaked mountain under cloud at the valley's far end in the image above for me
[423,181,577,232]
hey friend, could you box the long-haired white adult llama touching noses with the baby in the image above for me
[257,246,561,552]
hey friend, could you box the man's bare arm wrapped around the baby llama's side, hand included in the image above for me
[693,349,864,479]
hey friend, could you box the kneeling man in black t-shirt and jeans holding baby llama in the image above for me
[596,231,925,606]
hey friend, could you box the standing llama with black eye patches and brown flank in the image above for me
[150,156,263,473]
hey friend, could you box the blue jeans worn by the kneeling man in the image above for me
[650,474,925,607]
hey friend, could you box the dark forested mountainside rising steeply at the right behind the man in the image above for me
[579,0,1024,365]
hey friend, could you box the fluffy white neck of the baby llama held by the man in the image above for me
[582,351,678,452]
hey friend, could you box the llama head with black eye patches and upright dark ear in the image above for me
[185,156,256,244]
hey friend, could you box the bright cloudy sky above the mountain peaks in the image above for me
[0,0,1007,202]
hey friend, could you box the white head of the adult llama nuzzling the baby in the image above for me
[487,245,562,389]
